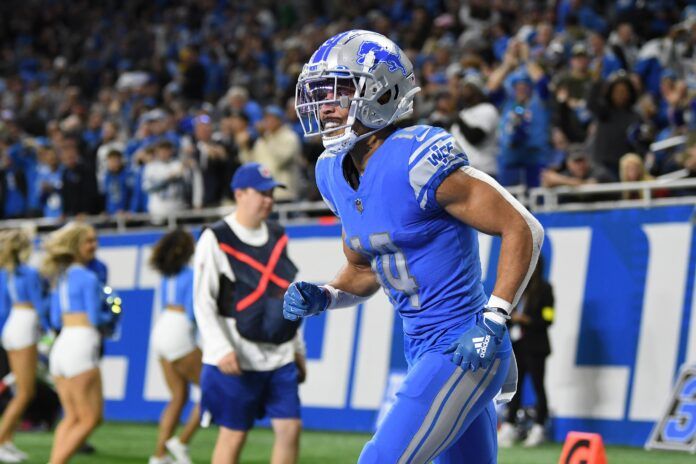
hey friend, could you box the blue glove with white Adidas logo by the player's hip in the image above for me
[445,308,509,371]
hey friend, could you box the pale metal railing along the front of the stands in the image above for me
[0,179,696,233]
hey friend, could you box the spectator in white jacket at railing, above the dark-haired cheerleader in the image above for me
[142,140,188,224]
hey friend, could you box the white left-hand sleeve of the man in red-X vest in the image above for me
[193,229,234,359]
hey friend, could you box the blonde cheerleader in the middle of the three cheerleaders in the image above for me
[41,223,113,464]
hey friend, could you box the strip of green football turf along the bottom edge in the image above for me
[10,422,696,464]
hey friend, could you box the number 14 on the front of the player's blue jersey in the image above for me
[350,233,420,308]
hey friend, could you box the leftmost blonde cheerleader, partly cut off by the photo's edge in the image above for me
[0,230,47,462]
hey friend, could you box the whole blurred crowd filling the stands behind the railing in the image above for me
[0,0,696,219]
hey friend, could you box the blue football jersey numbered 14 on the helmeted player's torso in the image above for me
[316,125,486,346]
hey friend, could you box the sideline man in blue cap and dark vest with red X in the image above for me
[194,163,305,464]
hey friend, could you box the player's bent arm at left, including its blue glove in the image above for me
[283,234,379,321]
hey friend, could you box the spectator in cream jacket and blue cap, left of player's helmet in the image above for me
[240,105,302,201]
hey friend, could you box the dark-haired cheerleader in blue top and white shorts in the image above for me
[149,229,202,464]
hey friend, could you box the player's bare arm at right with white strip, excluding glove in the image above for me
[436,166,544,320]
